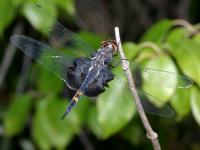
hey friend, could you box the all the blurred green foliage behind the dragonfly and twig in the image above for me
[0,0,200,149]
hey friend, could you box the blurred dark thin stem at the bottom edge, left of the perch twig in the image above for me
[79,129,94,150]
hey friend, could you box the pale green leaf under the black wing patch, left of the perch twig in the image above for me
[97,67,135,139]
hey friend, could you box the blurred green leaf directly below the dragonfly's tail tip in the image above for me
[32,97,81,149]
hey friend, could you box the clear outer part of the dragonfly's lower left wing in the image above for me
[10,35,76,84]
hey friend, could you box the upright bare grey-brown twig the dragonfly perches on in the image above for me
[115,27,161,150]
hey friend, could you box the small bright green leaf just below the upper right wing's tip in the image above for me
[170,88,191,119]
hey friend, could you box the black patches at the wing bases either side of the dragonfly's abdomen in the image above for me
[67,57,114,97]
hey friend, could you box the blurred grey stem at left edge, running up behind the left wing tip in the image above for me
[0,24,23,87]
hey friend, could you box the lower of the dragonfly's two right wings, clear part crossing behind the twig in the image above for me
[106,68,174,117]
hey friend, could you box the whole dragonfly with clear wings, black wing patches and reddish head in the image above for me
[10,5,192,119]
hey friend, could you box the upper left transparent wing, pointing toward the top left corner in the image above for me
[31,5,96,57]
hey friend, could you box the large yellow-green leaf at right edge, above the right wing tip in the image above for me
[168,29,200,85]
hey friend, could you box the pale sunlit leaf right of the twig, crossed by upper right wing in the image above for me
[142,55,177,106]
